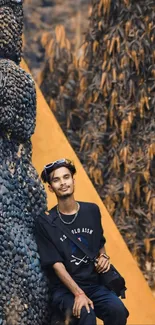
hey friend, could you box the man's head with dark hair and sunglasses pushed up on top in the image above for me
[41,158,76,199]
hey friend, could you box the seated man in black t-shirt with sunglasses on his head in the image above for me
[36,159,128,325]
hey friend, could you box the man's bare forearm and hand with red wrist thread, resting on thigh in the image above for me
[53,262,94,318]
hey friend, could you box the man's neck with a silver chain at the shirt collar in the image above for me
[58,197,77,214]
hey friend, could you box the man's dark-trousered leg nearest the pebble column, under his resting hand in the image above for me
[52,289,96,325]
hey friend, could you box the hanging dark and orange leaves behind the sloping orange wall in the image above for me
[40,0,155,286]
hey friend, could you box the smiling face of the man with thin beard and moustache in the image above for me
[49,167,74,199]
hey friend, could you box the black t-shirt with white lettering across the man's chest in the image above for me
[36,202,105,288]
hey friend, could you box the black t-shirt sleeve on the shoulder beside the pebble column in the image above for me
[35,220,63,267]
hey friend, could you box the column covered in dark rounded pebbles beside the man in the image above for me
[0,0,49,325]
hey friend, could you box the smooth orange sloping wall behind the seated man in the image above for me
[22,62,155,325]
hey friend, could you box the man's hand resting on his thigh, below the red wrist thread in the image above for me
[73,292,94,318]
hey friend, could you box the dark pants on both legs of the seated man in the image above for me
[52,284,129,325]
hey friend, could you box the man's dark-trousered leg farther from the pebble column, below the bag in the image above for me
[83,285,129,325]
